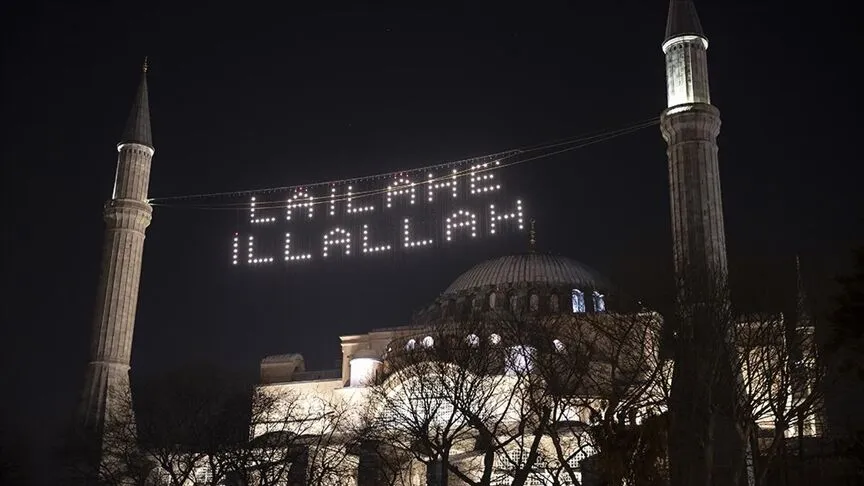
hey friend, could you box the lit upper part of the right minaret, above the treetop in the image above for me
[660,0,726,298]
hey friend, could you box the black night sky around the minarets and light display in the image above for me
[0,0,864,456]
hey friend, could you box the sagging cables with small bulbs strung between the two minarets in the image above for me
[148,117,660,211]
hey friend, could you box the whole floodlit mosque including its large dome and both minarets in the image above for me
[81,0,819,485]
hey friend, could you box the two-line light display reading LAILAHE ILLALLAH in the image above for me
[231,159,525,266]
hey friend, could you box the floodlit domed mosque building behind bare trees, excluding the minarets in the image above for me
[253,252,669,485]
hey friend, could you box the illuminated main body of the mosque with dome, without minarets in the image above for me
[254,252,663,485]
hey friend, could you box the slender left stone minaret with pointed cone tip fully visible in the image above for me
[81,60,154,438]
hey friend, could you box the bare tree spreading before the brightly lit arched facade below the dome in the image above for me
[370,322,532,485]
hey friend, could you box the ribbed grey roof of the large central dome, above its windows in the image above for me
[444,253,609,295]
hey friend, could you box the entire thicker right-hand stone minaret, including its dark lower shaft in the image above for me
[660,0,745,486]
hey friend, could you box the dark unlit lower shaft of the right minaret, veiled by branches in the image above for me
[669,265,746,486]
